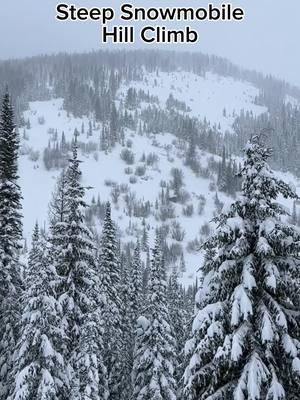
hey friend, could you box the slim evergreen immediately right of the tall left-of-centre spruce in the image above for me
[98,203,123,400]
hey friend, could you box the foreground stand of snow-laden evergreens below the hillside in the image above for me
[0,94,300,400]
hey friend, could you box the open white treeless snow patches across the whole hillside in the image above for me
[20,72,298,284]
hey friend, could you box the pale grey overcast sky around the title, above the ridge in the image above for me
[0,0,300,86]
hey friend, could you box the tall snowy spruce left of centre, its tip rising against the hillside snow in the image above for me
[52,140,108,400]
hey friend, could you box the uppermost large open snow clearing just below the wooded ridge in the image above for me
[120,71,267,132]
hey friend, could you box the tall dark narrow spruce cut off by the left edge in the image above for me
[0,93,22,400]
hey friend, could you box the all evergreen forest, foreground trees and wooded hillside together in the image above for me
[0,51,300,400]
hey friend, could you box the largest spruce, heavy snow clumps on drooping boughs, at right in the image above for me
[184,136,300,400]
